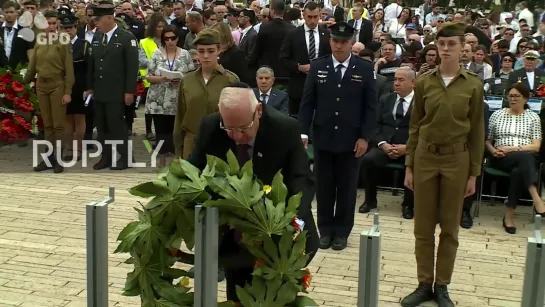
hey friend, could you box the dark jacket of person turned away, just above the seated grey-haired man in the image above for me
[253,18,295,83]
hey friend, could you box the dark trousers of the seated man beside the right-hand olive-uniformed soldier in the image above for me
[361,147,414,208]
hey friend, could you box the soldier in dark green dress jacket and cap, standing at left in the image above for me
[85,1,138,170]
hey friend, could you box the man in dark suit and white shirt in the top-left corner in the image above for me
[0,1,34,68]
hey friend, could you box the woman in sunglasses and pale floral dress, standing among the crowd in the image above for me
[146,26,194,167]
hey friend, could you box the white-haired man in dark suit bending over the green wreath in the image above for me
[189,85,318,301]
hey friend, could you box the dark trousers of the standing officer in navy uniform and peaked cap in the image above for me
[314,148,360,238]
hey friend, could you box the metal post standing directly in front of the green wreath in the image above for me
[194,206,219,307]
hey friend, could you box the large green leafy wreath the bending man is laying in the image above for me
[115,151,317,307]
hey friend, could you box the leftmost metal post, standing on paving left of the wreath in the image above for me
[86,187,115,307]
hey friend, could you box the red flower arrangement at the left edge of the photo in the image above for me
[0,69,41,144]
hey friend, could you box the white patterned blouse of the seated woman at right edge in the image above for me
[488,108,541,147]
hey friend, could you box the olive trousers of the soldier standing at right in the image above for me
[413,140,469,285]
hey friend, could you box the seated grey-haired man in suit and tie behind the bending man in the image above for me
[254,66,289,115]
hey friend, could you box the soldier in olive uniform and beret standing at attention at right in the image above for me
[401,23,484,307]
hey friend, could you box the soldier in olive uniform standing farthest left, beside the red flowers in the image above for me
[24,11,74,173]
